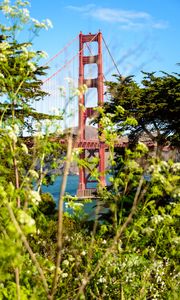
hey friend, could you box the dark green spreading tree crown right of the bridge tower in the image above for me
[105,72,180,146]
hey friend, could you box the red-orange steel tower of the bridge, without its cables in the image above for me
[77,32,106,198]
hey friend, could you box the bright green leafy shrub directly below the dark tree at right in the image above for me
[99,143,180,229]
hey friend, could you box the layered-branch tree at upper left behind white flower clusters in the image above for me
[0,1,58,131]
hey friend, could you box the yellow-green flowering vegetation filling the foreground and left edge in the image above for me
[0,0,180,300]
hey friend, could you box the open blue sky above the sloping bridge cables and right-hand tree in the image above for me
[30,0,180,78]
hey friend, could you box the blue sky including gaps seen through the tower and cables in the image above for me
[0,0,180,123]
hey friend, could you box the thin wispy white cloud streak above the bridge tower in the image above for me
[67,4,168,30]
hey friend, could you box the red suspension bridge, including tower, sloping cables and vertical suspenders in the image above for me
[35,32,124,198]
